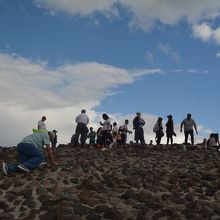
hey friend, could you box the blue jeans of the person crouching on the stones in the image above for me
[8,143,44,172]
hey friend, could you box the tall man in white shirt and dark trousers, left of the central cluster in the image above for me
[73,109,89,145]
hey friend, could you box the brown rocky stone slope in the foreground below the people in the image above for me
[0,145,220,220]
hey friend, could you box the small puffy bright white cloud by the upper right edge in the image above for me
[192,23,220,45]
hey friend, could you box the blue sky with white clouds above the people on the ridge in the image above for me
[0,0,220,145]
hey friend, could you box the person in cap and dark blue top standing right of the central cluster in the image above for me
[133,112,145,144]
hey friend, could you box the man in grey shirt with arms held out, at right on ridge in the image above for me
[180,114,198,145]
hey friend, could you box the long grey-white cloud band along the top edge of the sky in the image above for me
[33,0,220,30]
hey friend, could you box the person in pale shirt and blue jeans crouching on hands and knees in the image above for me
[2,132,57,175]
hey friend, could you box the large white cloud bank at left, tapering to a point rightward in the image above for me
[0,53,161,145]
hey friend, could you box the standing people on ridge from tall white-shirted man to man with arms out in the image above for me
[71,109,201,150]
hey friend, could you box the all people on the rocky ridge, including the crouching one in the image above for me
[2,109,219,175]
